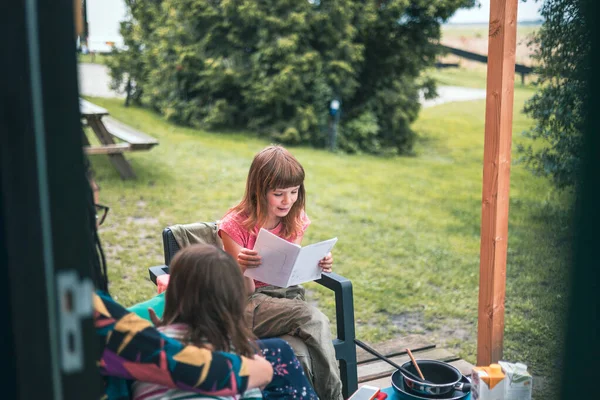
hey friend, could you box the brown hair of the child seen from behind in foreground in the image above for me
[163,244,255,357]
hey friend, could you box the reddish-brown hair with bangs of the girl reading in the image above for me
[229,145,306,239]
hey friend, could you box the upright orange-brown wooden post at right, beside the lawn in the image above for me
[477,0,518,365]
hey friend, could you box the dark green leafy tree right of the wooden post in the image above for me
[519,0,590,189]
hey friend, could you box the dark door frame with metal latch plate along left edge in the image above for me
[0,0,101,399]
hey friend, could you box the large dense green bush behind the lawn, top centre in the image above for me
[111,0,474,154]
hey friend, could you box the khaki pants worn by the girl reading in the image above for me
[246,286,343,400]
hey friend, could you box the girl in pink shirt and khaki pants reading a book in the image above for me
[218,146,342,400]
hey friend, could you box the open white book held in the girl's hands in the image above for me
[244,229,337,287]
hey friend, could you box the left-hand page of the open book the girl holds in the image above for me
[244,229,300,287]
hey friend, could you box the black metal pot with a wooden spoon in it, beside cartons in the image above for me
[399,360,471,396]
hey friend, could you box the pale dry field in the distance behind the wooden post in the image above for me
[441,24,540,68]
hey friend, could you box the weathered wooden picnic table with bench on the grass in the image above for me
[79,98,158,179]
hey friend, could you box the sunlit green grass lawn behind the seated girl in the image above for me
[90,71,570,398]
